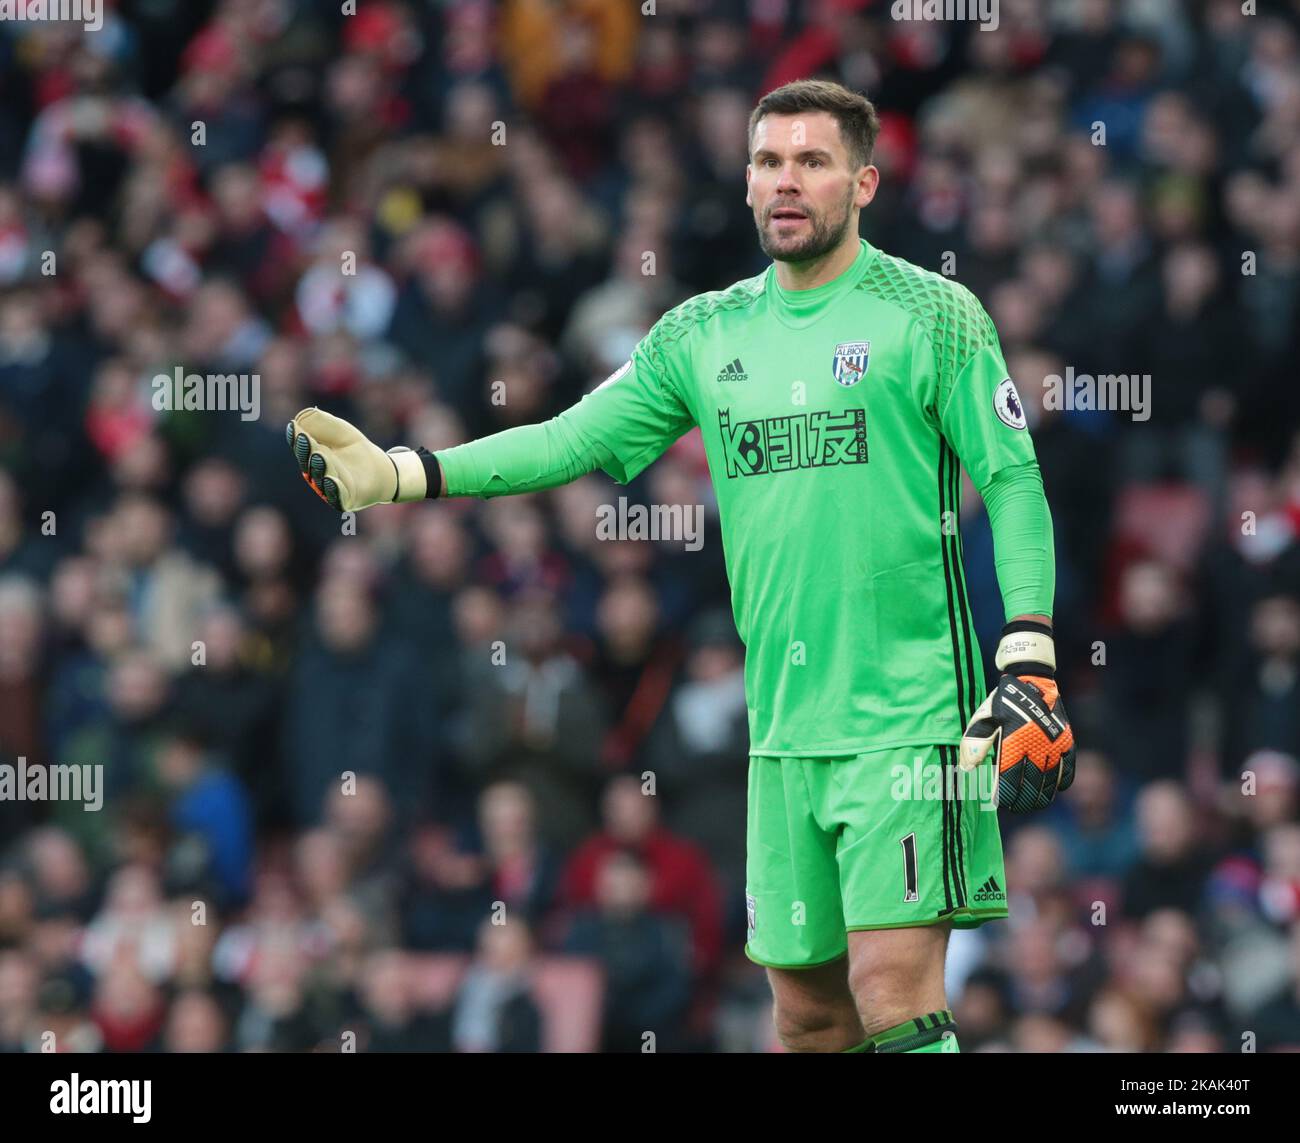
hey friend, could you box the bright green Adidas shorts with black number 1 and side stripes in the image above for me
[745,746,1006,969]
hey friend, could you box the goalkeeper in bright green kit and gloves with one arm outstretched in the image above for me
[287,81,1074,1052]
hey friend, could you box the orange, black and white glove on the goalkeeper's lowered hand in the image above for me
[959,619,1074,814]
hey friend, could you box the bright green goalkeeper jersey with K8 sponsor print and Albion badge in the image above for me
[437,241,1052,755]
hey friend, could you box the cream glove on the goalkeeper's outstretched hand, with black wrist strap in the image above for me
[285,408,437,512]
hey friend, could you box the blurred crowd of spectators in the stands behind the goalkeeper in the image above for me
[0,0,1300,1052]
